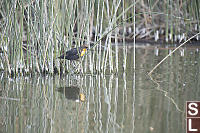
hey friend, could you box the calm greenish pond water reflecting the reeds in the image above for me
[0,46,200,133]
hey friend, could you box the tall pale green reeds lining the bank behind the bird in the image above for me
[0,0,200,75]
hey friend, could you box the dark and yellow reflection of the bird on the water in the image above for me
[57,86,85,102]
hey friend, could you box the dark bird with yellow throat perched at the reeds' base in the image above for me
[58,45,88,60]
